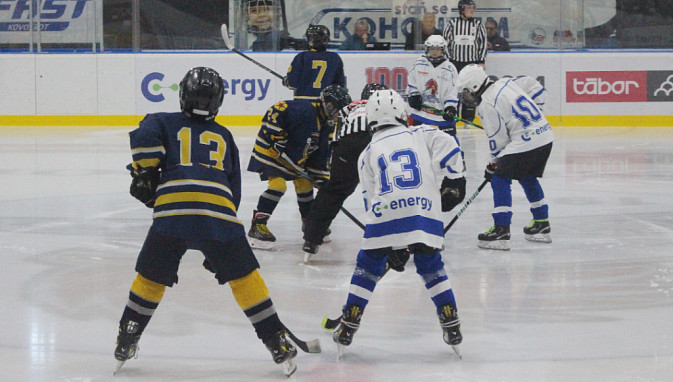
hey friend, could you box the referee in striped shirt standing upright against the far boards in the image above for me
[444,0,488,72]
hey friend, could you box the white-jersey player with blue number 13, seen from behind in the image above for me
[333,90,465,355]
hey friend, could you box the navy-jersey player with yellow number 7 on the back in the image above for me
[283,25,346,101]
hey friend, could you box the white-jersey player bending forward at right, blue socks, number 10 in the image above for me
[456,65,554,250]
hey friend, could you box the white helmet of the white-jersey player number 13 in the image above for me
[365,89,409,131]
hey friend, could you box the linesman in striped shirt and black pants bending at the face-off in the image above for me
[303,84,386,262]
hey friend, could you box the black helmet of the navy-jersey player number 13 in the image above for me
[180,67,225,121]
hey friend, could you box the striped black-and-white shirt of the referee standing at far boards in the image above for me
[443,17,487,64]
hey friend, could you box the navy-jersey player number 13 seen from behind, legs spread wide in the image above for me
[114,67,304,374]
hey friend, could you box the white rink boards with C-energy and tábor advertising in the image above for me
[0,51,673,125]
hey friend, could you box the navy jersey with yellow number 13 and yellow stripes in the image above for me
[129,113,245,241]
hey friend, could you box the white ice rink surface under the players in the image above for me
[0,127,673,382]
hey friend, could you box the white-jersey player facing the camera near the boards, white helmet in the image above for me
[407,35,458,135]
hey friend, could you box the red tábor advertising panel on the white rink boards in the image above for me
[566,70,648,102]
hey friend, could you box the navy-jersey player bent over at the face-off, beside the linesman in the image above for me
[248,92,332,249]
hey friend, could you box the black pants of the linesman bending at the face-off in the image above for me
[304,132,371,244]
